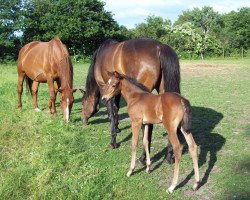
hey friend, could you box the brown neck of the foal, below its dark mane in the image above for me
[121,78,145,104]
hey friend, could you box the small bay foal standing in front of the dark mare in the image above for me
[102,72,199,193]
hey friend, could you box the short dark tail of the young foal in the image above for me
[181,98,192,133]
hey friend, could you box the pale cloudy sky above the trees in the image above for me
[103,0,250,28]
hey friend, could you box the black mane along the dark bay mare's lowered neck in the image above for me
[83,39,117,99]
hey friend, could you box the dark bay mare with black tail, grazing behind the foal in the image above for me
[81,38,180,160]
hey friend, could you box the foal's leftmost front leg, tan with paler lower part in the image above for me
[127,119,141,177]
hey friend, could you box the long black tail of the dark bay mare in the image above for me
[160,45,180,93]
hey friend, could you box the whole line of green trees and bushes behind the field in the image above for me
[0,0,250,60]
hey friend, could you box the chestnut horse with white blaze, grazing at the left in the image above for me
[17,37,75,122]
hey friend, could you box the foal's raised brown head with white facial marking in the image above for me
[101,71,123,101]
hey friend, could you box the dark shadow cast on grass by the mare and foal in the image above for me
[147,106,226,188]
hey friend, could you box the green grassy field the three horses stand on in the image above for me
[0,59,250,200]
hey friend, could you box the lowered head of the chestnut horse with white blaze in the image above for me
[58,87,76,122]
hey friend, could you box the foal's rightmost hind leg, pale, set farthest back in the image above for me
[181,129,200,190]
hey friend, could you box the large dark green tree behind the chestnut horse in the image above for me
[23,0,119,55]
